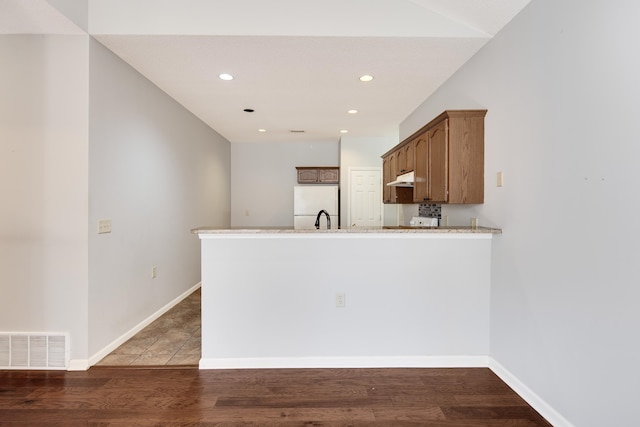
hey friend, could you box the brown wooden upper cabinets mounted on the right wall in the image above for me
[384,110,487,204]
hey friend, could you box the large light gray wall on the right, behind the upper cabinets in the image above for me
[400,0,640,427]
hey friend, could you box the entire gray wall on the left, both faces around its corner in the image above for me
[0,35,230,369]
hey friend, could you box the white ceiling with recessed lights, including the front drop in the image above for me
[0,0,530,143]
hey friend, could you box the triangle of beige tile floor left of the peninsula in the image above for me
[97,289,201,366]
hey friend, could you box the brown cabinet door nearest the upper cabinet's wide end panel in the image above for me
[427,120,449,203]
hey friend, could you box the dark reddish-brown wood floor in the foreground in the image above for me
[0,367,550,427]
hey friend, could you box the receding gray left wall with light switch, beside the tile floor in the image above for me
[89,40,231,362]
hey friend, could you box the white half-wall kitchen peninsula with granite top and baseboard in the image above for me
[192,227,501,369]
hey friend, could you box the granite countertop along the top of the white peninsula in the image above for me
[191,226,502,234]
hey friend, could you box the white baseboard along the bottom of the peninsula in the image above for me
[199,356,489,369]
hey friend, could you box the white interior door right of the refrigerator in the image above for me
[349,168,382,227]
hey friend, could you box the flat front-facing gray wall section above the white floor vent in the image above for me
[0,35,89,358]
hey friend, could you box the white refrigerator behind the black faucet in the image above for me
[293,185,339,230]
